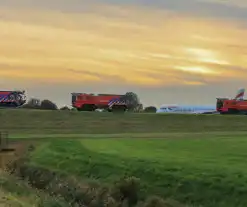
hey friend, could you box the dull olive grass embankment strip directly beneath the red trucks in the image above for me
[0,109,247,136]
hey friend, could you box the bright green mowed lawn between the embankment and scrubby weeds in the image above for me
[31,135,247,207]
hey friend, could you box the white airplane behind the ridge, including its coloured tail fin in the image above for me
[156,88,245,114]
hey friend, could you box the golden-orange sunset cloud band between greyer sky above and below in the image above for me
[0,5,247,86]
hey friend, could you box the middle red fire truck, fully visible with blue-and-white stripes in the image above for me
[71,93,127,112]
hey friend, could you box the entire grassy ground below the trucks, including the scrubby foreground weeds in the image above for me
[0,109,247,207]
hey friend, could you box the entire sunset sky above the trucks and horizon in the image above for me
[0,0,247,107]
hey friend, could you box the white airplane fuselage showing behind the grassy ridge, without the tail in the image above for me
[156,105,216,114]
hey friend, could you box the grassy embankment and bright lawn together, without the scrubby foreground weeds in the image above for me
[0,110,247,207]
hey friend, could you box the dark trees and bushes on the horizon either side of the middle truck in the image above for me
[22,92,157,113]
